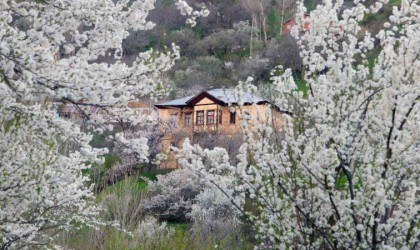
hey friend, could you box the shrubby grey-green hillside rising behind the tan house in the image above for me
[117,0,400,99]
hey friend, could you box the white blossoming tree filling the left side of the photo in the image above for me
[0,0,208,249]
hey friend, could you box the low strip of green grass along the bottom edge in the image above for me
[58,224,253,250]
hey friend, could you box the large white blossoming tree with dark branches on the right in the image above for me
[179,0,420,249]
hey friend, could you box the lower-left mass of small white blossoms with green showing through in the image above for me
[0,97,106,248]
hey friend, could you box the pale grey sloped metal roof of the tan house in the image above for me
[155,89,267,107]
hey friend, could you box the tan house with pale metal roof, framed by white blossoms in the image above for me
[155,89,282,168]
